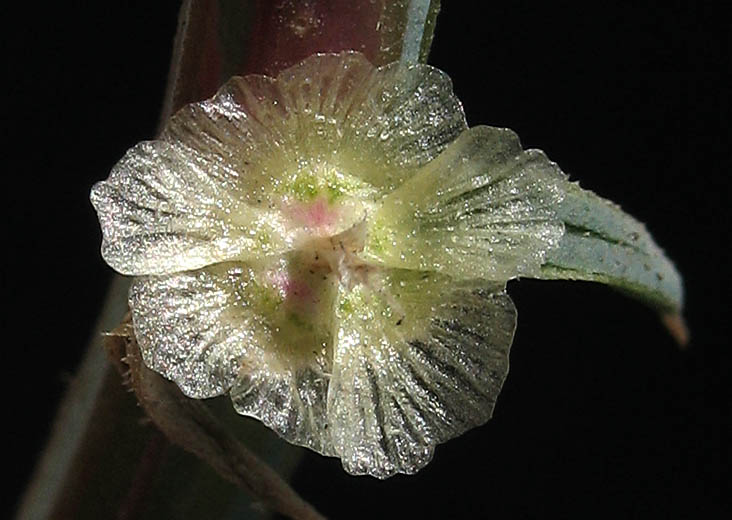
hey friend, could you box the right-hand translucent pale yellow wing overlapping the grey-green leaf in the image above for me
[365,126,568,281]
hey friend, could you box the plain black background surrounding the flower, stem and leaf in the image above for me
[0,1,732,518]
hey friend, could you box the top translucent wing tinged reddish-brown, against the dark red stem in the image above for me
[169,52,467,197]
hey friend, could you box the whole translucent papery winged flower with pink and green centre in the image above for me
[91,52,567,478]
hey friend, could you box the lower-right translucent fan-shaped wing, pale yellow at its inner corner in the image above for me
[328,270,516,478]
